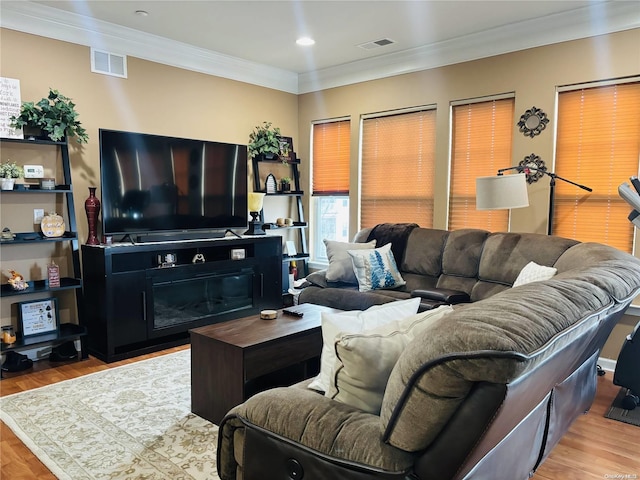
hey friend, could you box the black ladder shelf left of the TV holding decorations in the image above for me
[0,138,88,358]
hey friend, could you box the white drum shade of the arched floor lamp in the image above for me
[476,173,529,210]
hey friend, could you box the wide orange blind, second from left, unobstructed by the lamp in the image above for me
[360,110,436,228]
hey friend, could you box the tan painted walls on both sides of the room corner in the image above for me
[0,29,640,358]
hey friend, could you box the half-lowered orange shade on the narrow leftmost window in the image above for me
[312,120,351,195]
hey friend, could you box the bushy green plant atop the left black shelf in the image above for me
[9,88,89,143]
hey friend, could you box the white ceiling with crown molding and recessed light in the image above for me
[0,0,640,93]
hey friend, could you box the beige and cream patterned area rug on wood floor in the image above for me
[0,350,218,480]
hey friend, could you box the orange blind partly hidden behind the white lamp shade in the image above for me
[449,98,515,232]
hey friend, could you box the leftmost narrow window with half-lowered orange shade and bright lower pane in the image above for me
[311,120,351,262]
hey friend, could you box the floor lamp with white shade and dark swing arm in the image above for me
[476,165,593,235]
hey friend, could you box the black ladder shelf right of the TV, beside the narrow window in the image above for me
[252,154,309,293]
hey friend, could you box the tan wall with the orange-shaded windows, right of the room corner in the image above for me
[298,29,640,359]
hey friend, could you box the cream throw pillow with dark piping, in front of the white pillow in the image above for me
[327,305,453,415]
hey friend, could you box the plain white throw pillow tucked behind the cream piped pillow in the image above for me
[308,297,420,393]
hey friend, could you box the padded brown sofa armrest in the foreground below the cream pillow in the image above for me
[218,386,415,478]
